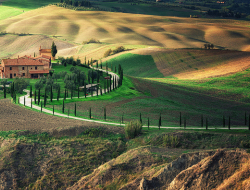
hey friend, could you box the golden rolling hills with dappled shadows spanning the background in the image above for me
[0,6,250,50]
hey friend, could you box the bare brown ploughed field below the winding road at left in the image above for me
[0,99,123,133]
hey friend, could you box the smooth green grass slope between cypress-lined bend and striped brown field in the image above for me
[103,53,163,78]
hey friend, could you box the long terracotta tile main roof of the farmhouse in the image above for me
[2,59,44,66]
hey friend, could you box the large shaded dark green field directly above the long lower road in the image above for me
[59,77,250,127]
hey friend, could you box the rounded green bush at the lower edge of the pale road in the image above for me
[125,120,142,139]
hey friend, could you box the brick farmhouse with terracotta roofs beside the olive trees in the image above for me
[0,55,51,78]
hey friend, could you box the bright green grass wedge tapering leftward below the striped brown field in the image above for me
[148,67,250,103]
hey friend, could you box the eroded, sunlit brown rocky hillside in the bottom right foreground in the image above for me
[68,148,250,190]
